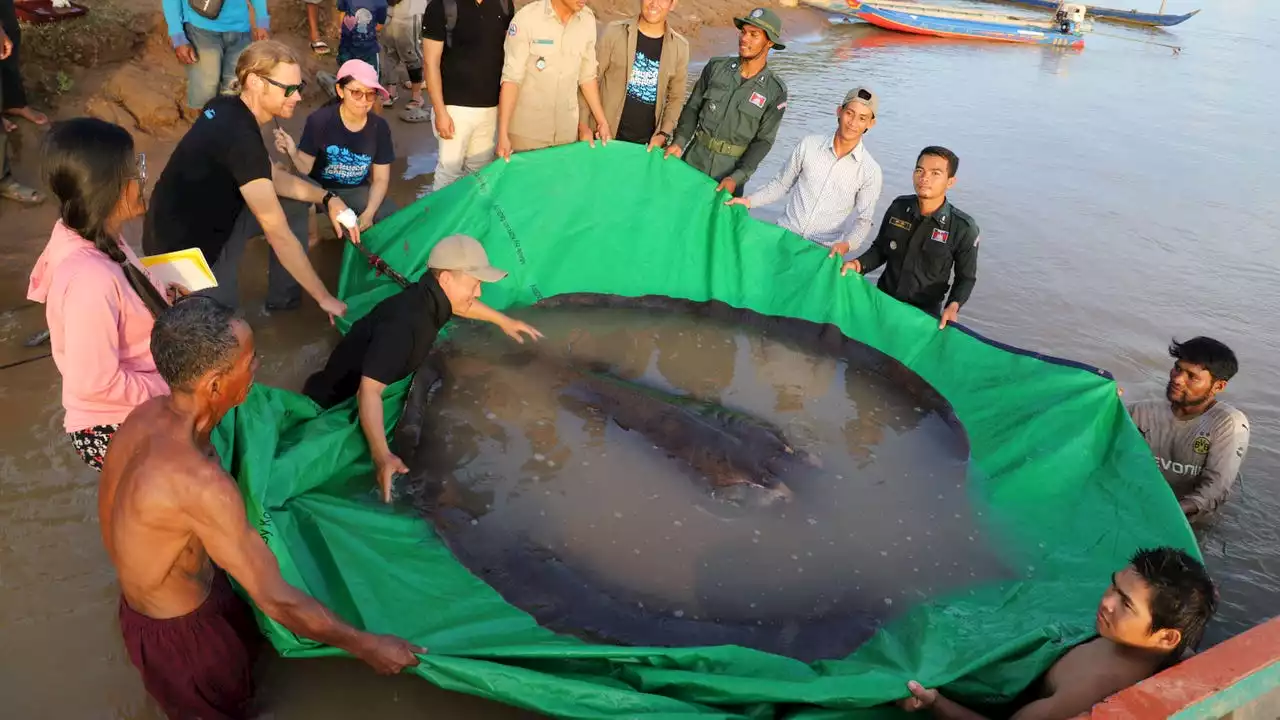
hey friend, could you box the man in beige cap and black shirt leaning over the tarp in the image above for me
[302,234,543,502]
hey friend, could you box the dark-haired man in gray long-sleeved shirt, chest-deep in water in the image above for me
[1129,337,1249,523]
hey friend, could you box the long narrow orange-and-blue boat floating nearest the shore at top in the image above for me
[800,0,1089,47]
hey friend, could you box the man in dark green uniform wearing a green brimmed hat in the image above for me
[666,8,787,197]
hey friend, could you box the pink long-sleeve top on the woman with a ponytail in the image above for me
[27,220,169,433]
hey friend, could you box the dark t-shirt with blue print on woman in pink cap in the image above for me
[298,102,396,190]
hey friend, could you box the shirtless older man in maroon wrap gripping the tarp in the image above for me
[97,296,426,720]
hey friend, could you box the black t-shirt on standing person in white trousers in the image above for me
[422,0,515,108]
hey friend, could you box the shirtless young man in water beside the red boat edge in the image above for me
[899,547,1217,720]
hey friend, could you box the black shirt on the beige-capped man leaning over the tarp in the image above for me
[302,272,453,407]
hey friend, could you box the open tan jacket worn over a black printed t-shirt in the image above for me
[577,18,689,138]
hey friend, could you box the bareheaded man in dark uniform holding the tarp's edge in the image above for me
[840,146,978,331]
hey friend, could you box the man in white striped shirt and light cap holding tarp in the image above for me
[728,87,882,259]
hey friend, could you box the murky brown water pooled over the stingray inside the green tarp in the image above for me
[406,297,1007,660]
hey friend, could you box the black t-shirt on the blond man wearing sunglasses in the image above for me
[142,96,271,264]
